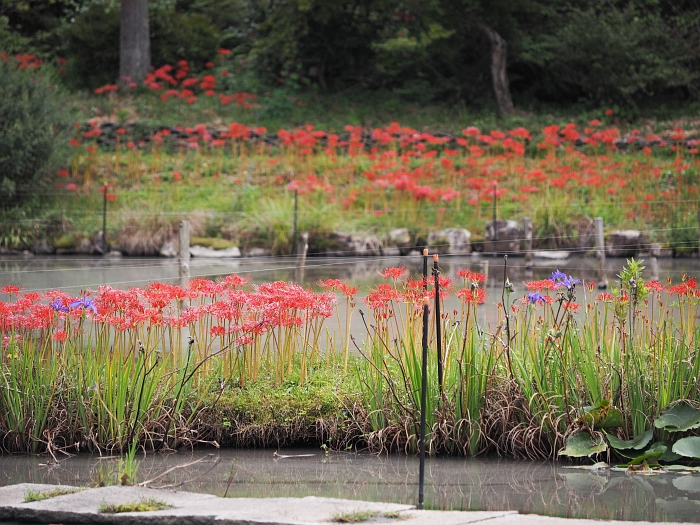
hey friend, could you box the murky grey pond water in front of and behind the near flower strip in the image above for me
[0,256,700,522]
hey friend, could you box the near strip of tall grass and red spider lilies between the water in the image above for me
[0,261,700,458]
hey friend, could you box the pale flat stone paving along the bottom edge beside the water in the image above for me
[0,483,688,525]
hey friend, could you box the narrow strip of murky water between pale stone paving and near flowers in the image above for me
[0,449,700,522]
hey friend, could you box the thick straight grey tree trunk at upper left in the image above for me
[119,0,151,86]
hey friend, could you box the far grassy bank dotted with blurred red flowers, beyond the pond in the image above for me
[6,113,700,255]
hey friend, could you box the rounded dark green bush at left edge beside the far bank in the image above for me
[0,60,67,207]
